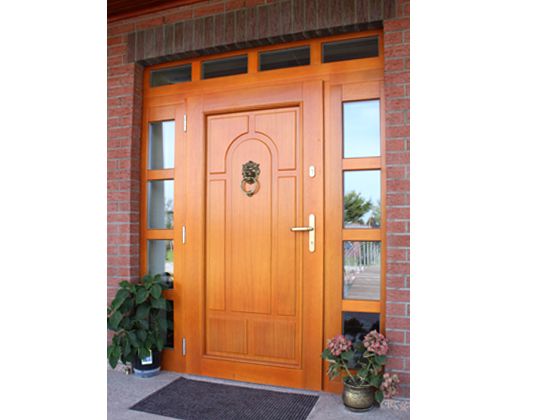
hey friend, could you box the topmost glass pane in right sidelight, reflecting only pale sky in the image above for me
[342,100,381,158]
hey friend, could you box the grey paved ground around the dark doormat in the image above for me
[107,370,410,420]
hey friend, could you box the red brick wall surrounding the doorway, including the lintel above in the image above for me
[107,0,410,397]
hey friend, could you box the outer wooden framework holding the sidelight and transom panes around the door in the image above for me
[139,30,387,392]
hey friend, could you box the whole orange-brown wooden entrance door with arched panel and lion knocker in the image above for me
[184,81,323,389]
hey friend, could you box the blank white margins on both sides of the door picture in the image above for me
[0,0,560,420]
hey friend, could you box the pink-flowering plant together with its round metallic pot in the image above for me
[322,331,399,412]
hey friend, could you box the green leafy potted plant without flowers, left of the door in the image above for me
[107,274,171,377]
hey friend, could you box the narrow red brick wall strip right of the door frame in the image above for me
[383,1,410,397]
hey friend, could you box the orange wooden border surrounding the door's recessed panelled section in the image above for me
[184,81,324,389]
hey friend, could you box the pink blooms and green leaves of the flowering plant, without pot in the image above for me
[321,331,399,403]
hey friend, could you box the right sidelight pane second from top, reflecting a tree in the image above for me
[344,170,381,229]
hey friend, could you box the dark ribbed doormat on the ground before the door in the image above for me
[130,378,319,420]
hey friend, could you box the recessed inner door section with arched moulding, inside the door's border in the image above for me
[206,107,302,365]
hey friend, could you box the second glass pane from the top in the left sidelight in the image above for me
[148,180,173,229]
